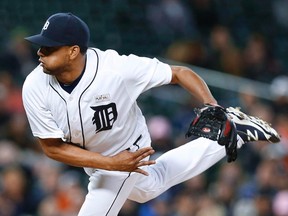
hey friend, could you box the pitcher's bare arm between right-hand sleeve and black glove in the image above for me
[171,66,217,104]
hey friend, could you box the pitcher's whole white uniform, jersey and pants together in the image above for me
[23,49,225,216]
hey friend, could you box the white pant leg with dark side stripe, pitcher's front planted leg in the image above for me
[78,170,140,216]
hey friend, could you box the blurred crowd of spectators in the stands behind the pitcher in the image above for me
[0,0,288,216]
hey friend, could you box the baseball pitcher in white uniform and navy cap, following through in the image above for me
[23,13,279,216]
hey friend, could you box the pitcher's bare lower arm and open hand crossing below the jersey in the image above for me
[39,138,155,175]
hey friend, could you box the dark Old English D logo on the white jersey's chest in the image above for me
[91,103,118,133]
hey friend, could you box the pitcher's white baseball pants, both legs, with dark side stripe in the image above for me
[78,138,226,216]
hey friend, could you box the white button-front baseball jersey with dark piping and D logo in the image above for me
[23,49,172,155]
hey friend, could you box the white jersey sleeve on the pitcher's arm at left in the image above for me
[22,70,64,139]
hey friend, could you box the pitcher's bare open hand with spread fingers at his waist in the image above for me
[110,147,155,176]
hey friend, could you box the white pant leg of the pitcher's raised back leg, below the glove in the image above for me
[128,138,226,203]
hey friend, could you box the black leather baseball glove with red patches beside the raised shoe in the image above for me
[185,105,237,162]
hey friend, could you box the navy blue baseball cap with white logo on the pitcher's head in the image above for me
[25,13,90,47]
